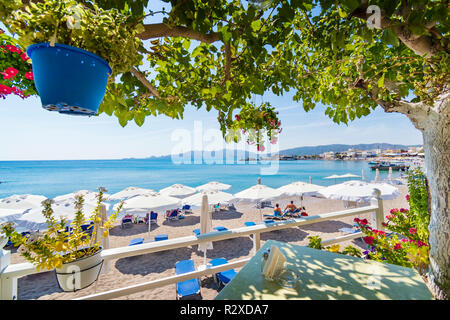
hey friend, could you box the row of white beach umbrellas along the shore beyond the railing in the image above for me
[0,180,399,229]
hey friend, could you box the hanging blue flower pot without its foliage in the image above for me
[27,43,112,116]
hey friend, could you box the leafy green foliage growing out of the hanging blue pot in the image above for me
[5,0,143,77]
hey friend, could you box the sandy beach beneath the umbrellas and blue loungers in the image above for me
[11,185,408,300]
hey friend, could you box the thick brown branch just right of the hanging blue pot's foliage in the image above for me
[138,23,220,43]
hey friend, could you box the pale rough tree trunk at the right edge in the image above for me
[422,110,450,299]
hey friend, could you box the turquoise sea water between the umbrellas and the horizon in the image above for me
[0,159,399,198]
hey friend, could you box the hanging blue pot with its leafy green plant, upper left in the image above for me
[5,0,142,115]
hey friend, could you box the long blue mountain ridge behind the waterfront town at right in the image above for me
[280,143,421,156]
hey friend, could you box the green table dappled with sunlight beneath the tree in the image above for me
[215,240,433,300]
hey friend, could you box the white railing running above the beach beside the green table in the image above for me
[0,198,384,300]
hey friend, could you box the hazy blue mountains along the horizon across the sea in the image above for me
[146,143,421,162]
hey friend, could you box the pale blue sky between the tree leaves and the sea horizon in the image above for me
[0,2,423,161]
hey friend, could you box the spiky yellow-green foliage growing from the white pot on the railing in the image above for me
[0,188,123,270]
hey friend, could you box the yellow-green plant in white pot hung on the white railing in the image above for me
[0,188,123,291]
